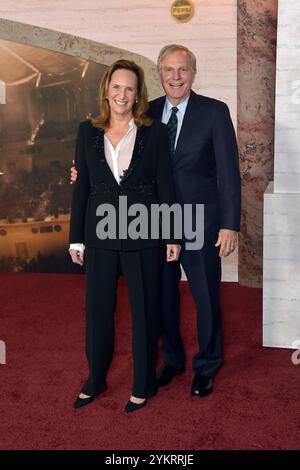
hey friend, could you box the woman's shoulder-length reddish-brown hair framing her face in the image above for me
[91,59,152,130]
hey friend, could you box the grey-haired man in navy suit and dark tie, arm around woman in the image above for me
[150,45,241,397]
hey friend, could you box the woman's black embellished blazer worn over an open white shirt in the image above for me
[69,121,176,250]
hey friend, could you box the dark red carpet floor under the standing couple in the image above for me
[0,273,300,450]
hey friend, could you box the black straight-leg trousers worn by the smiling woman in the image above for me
[81,247,162,398]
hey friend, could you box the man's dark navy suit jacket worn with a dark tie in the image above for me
[149,91,241,246]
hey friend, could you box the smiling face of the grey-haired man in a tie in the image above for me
[160,51,195,106]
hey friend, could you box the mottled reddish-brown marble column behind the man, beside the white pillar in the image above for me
[237,0,277,287]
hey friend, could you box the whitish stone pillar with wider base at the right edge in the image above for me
[263,0,300,349]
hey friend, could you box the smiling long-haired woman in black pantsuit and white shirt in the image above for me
[69,60,180,412]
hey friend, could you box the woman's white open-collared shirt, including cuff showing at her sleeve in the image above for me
[69,119,137,251]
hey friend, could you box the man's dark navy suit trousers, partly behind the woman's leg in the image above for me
[161,243,223,377]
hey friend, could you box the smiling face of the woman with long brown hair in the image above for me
[107,69,137,115]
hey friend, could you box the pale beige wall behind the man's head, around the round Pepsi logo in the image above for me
[0,0,236,122]
